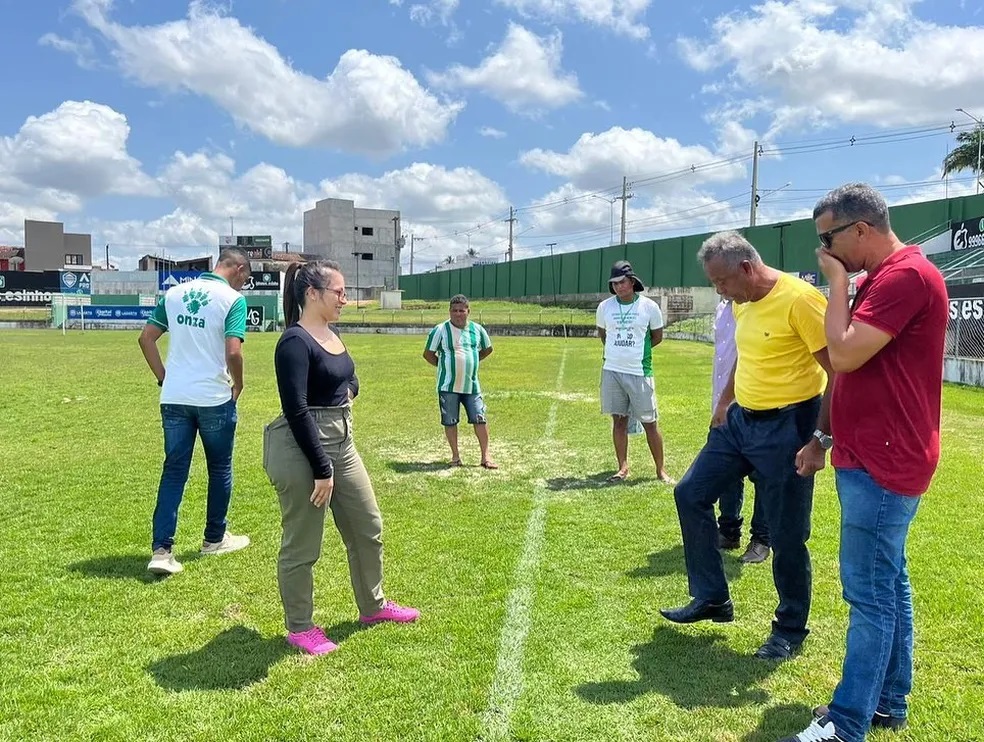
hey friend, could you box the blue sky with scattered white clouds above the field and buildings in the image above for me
[0,0,984,270]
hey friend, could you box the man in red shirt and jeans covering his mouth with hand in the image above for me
[783,183,948,742]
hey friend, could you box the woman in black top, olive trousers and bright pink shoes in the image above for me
[263,260,419,654]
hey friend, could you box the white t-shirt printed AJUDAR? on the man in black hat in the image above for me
[595,294,663,376]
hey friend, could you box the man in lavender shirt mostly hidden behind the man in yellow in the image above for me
[711,299,769,564]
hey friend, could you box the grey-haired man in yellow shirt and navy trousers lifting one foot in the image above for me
[660,232,833,660]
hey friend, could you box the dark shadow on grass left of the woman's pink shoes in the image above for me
[147,626,295,691]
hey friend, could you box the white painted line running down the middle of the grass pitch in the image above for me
[479,344,570,742]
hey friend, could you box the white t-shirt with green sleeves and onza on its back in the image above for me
[148,273,252,407]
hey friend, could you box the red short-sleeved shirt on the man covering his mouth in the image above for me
[830,247,948,496]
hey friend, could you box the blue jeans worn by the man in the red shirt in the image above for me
[830,469,919,742]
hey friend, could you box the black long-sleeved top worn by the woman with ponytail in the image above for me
[273,325,359,479]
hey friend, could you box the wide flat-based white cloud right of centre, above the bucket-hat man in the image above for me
[520,126,745,190]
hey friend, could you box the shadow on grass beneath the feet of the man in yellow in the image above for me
[575,626,776,712]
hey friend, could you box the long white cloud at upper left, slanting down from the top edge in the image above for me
[75,0,463,155]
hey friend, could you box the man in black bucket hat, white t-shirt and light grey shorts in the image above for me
[595,260,673,483]
